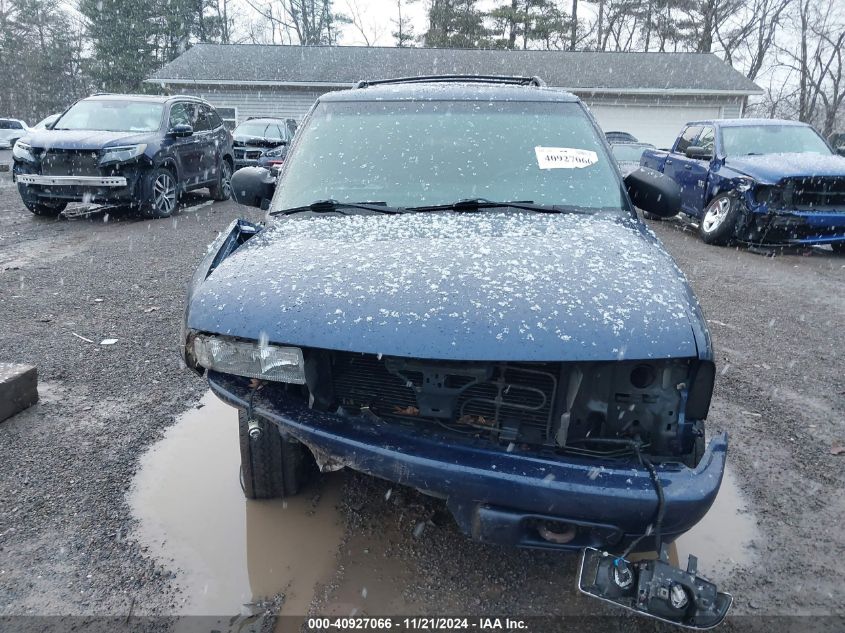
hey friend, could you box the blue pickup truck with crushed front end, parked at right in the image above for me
[640,119,845,253]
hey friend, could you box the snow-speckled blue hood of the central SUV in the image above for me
[187,212,706,361]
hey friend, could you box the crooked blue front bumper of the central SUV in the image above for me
[207,371,727,551]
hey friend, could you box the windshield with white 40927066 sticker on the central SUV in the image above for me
[273,101,624,210]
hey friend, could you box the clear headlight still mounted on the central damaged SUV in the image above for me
[194,334,305,385]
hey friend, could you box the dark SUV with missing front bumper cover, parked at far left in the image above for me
[13,94,233,218]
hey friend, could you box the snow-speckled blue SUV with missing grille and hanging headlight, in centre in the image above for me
[182,79,727,550]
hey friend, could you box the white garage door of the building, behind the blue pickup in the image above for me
[590,104,721,147]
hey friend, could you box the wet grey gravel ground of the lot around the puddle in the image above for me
[0,148,845,628]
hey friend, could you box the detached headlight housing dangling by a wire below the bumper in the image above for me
[578,544,733,629]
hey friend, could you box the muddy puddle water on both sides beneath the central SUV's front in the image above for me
[134,393,759,616]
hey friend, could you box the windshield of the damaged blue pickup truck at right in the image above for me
[722,125,830,156]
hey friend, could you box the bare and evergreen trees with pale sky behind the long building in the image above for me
[0,0,845,134]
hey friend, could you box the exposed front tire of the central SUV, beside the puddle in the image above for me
[238,409,310,499]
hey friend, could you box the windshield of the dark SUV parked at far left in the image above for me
[53,99,164,132]
